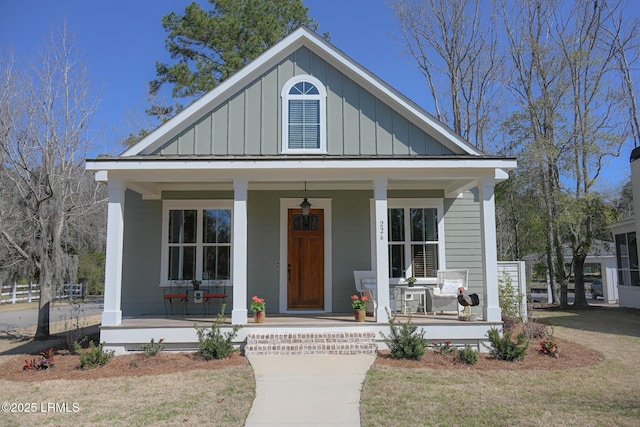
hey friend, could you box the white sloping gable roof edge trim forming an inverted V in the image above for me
[121,27,484,157]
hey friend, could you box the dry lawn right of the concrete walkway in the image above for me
[360,308,640,427]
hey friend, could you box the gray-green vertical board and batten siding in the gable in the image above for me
[149,47,455,156]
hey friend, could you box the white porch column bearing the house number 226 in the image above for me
[373,178,389,323]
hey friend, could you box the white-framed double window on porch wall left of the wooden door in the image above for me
[162,201,232,283]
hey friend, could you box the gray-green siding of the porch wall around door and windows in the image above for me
[121,190,482,316]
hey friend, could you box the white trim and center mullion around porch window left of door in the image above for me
[160,200,233,287]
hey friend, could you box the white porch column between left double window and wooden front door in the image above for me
[231,178,249,325]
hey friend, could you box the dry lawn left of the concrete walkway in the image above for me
[0,365,255,426]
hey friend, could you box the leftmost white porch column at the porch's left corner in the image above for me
[102,178,126,326]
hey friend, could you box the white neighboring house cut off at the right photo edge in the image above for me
[611,148,640,308]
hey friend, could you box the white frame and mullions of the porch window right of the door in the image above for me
[386,199,446,285]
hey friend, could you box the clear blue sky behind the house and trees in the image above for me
[0,0,640,191]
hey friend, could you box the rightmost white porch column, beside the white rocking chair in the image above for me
[478,177,502,322]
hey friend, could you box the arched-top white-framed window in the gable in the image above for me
[281,75,327,153]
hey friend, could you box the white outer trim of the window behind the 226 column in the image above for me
[371,198,447,285]
